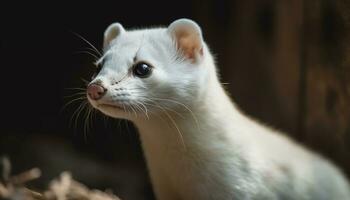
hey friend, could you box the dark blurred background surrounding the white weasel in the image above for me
[0,0,350,199]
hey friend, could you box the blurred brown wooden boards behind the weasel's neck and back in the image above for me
[194,0,350,174]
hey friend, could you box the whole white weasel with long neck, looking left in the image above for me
[87,19,350,200]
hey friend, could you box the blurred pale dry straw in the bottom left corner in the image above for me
[0,158,120,200]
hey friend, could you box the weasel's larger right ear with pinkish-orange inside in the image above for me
[168,19,203,62]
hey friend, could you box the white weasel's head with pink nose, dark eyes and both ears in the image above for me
[87,19,210,120]
